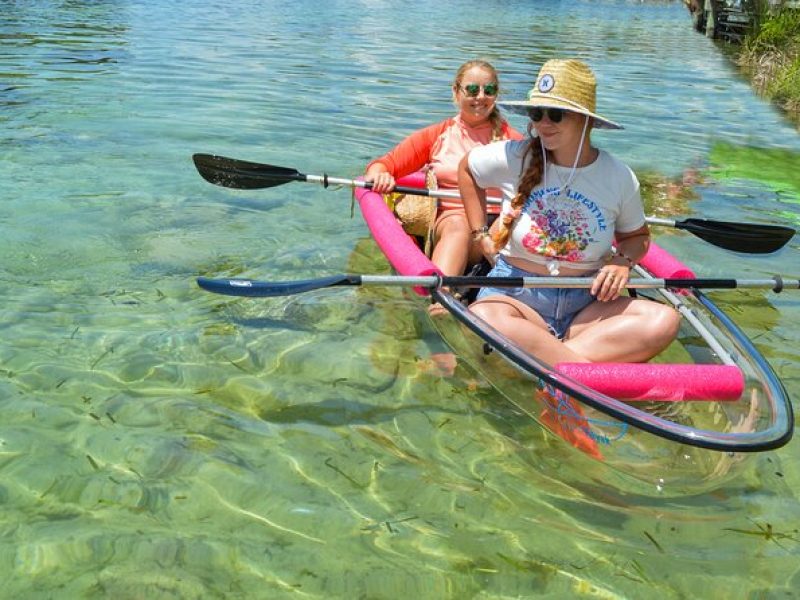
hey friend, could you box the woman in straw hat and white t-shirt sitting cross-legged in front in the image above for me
[459,60,680,364]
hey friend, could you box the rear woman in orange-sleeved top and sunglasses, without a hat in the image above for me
[364,60,523,275]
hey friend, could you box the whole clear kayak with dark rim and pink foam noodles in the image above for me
[355,176,794,492]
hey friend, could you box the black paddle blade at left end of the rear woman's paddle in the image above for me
[192,154,306,190]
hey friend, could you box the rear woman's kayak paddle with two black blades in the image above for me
[192,154,796,254]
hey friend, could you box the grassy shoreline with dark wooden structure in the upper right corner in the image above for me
[684,0,800,129]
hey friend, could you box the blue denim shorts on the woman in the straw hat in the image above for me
[477,256,595,339]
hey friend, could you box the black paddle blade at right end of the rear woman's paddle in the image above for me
[675,219,796,254]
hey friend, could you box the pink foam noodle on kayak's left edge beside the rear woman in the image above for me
[355,173,441,296]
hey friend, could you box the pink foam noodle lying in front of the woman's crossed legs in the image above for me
[556,363,744,402]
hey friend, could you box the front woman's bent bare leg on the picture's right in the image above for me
[564,297,680,362]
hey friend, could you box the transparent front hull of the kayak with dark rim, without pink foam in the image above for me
[431,291,793,493]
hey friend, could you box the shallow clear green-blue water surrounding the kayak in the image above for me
[0,0,800,598]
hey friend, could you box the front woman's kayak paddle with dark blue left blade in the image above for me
[197,275,800,298]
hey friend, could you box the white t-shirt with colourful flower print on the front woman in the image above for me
[469,140,645,270]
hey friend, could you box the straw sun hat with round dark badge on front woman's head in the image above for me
[497,59,622,129]
